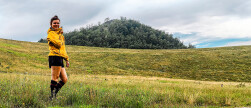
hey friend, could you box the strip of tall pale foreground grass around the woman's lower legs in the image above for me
[0,73,251,108]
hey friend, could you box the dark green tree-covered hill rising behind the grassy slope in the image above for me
[39,17,194,49]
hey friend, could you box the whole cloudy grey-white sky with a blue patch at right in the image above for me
[0,0,251,48]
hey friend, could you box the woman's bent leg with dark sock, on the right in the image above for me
[55,68,68,94]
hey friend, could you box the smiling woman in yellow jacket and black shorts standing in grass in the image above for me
[47,15,69,99]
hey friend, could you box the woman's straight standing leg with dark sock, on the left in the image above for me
[50,66,62,99]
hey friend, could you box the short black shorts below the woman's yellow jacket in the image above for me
[49,56,64,68]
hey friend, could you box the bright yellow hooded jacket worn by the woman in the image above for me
[47,28,69,61]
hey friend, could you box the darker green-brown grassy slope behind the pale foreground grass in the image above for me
[0,39,251,82]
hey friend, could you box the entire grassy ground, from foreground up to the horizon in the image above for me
[0,39,251,108]
